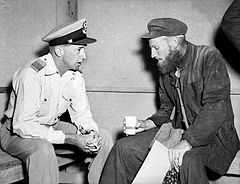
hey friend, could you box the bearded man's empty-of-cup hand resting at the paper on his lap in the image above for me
[168,140,192,168]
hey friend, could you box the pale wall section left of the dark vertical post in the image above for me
[0,0,56,87]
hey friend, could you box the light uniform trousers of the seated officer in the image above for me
[0,120,113,184]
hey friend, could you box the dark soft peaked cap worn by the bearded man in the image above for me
[142,18,187,39]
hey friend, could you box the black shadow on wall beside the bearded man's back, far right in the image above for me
[214,27,240,74]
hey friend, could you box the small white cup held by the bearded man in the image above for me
[124,116,137,135]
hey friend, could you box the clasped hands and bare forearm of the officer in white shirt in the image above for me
[65,131,102,154]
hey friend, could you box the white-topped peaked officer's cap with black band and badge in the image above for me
[42,19,96,46]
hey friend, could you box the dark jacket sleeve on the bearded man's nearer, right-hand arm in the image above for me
[183,52,230,147]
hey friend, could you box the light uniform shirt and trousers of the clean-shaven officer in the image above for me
[1,54,112,184]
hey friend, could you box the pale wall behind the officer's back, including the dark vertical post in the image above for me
[0,0,77,117]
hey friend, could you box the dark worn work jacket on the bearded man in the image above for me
[150,42,240,174]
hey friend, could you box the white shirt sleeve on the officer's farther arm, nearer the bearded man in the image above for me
[68,72,98,132]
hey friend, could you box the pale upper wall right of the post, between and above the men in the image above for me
[78,0,239,91]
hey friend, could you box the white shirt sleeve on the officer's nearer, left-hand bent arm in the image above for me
[13,69,65,143]
